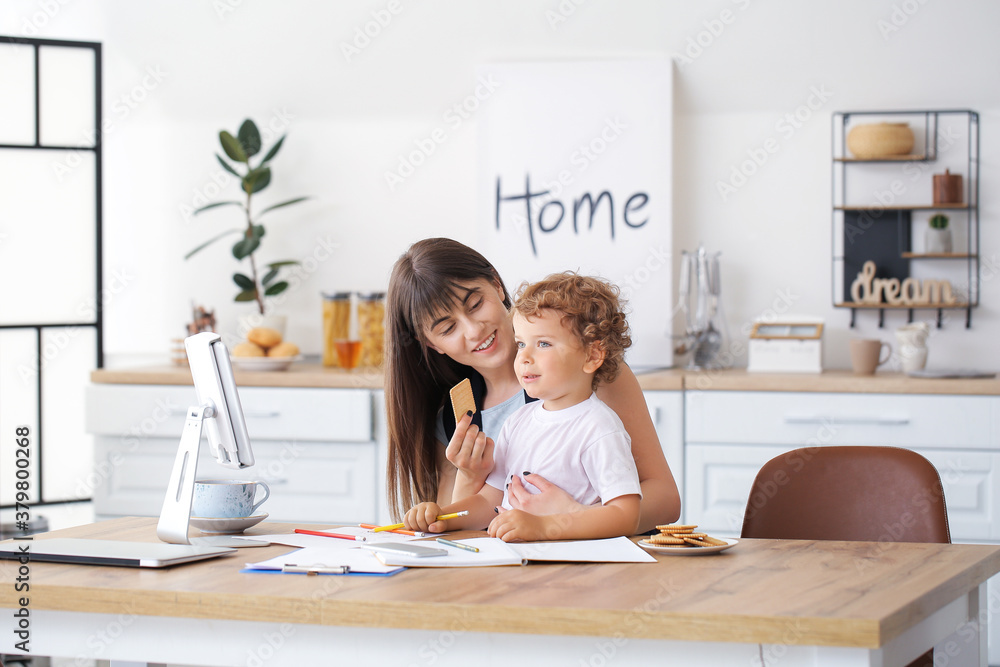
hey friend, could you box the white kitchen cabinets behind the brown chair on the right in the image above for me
[683,391,1000,664]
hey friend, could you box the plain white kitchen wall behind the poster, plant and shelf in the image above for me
[0,0,1000,367]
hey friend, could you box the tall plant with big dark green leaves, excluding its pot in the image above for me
[184,119,308,332]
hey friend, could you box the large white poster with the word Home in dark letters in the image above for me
[476,59,674,366]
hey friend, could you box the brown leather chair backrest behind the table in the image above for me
[742,447,951,543]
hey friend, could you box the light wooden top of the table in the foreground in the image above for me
[0,517,1000,648]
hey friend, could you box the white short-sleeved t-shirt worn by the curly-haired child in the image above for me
[486,394,642,509]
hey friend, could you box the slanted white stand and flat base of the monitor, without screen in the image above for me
[156,405,270,548]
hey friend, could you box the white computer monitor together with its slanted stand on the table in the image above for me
[156,331,267,546]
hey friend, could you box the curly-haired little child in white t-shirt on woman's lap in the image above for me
[403,272,641,542]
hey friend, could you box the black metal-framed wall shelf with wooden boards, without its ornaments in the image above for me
[832,110,979,327]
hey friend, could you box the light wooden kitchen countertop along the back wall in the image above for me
[90,363,1000,396]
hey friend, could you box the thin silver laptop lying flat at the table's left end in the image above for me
[0,537,236,567]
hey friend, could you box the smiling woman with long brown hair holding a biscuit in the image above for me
[385,238,680,531]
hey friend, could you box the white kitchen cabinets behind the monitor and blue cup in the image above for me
[86,384,381,523]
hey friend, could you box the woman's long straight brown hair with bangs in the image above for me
[385,238,510,518]
